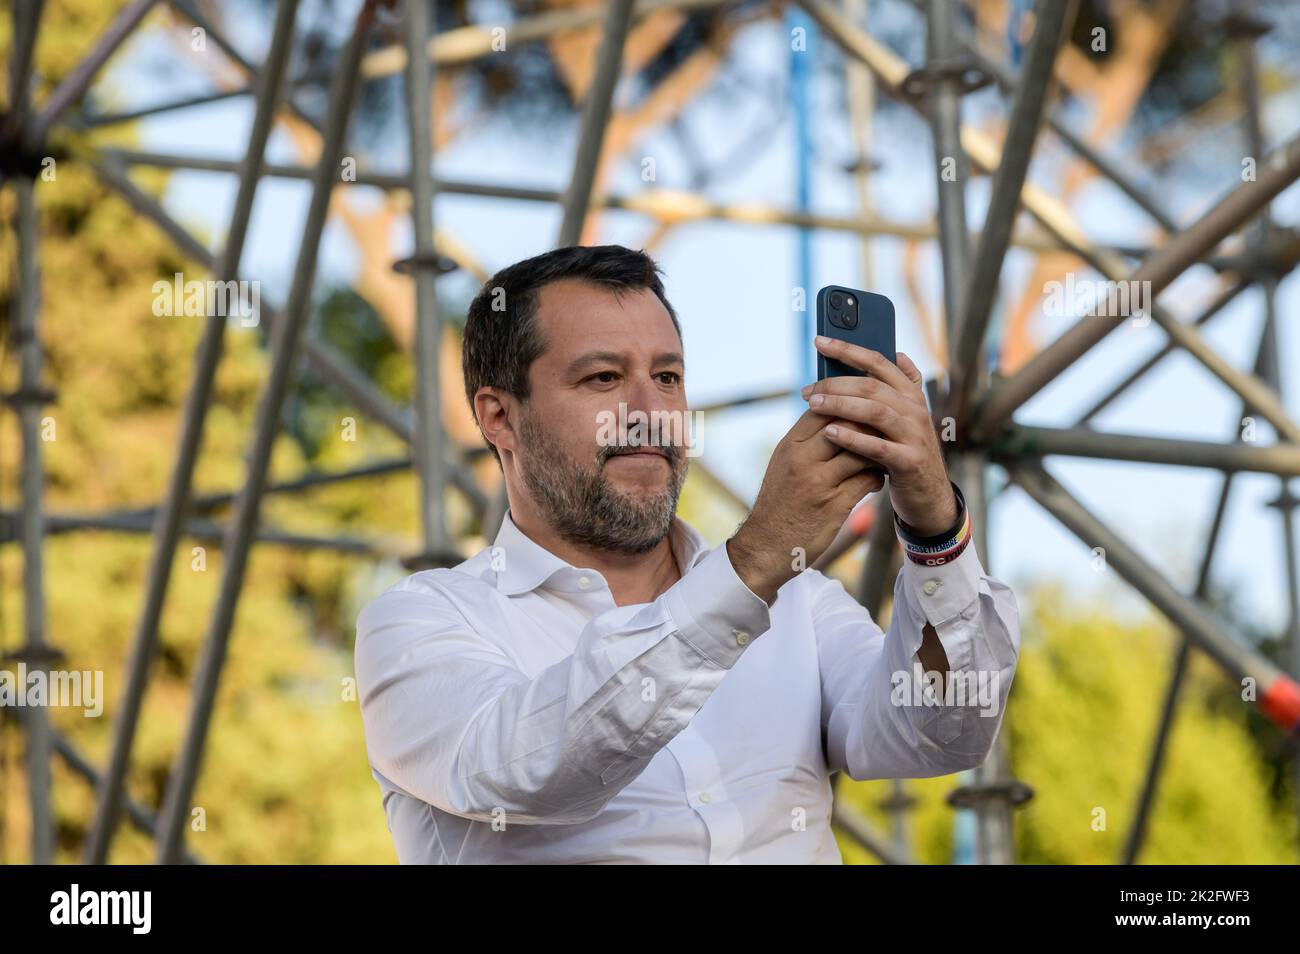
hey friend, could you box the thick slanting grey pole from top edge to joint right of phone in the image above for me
[949,0,1076,422]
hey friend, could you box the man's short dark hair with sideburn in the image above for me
[460,246,681,463]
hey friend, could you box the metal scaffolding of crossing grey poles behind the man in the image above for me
[0,0,1300,863]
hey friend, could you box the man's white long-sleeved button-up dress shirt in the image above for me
[356,513,1019,864]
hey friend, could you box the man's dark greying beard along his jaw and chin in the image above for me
[519,411,688,555]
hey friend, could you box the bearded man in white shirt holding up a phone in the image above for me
[356,246,1019,863]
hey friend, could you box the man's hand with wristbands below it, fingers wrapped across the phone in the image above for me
[803,335,958,537]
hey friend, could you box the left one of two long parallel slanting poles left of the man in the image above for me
[86,0,298,864]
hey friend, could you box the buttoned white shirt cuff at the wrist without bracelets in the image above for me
[663,545,772,669]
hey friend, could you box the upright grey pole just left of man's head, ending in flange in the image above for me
[403,0,463,569]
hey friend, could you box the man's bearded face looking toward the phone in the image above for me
[516,281,688,554]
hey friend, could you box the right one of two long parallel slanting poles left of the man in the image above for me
[157,0,376,863]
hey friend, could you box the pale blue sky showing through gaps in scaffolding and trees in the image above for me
[108,3,1300,642]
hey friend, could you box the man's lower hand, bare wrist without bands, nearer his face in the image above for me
[727,411,884,604]
